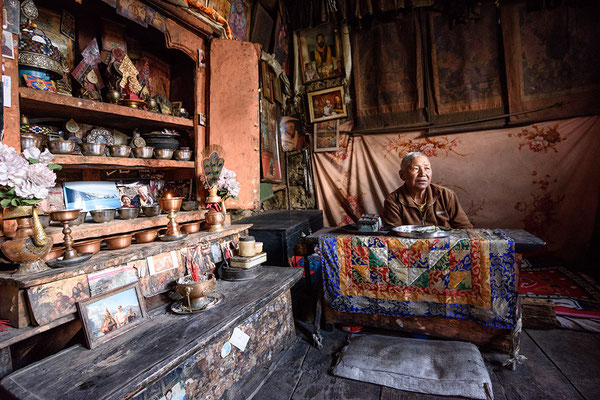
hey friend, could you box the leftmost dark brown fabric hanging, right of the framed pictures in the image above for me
[352,13,424,129]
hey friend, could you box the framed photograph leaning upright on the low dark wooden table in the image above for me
[77,283,148,349]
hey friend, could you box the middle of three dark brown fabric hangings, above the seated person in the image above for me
[429,4,504,115]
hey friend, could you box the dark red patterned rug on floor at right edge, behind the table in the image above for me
[519,265,600,319]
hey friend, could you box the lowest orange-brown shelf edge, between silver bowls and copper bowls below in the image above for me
[45,210,206,244]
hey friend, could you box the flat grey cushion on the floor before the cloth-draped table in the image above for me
[332,335,493,399]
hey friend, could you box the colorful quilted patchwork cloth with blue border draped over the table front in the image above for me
[319,229,517,329]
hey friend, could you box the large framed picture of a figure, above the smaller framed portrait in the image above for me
[298,24,344,83]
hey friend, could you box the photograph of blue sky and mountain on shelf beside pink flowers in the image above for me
[63,181,121,211]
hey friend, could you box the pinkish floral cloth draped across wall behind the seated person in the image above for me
[313,116,600,259]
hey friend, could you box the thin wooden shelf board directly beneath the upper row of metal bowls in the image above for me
[53,155,194,169]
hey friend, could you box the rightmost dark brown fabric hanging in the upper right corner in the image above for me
[501,1,600,121]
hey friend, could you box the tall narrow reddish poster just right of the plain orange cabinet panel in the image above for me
[260,99,281,182]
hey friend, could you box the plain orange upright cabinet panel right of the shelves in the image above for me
[207,39,260,209]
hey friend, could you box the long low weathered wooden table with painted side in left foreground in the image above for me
[0,267,301,400]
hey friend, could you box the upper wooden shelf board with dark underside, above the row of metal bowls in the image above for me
[19,87,194,130]
